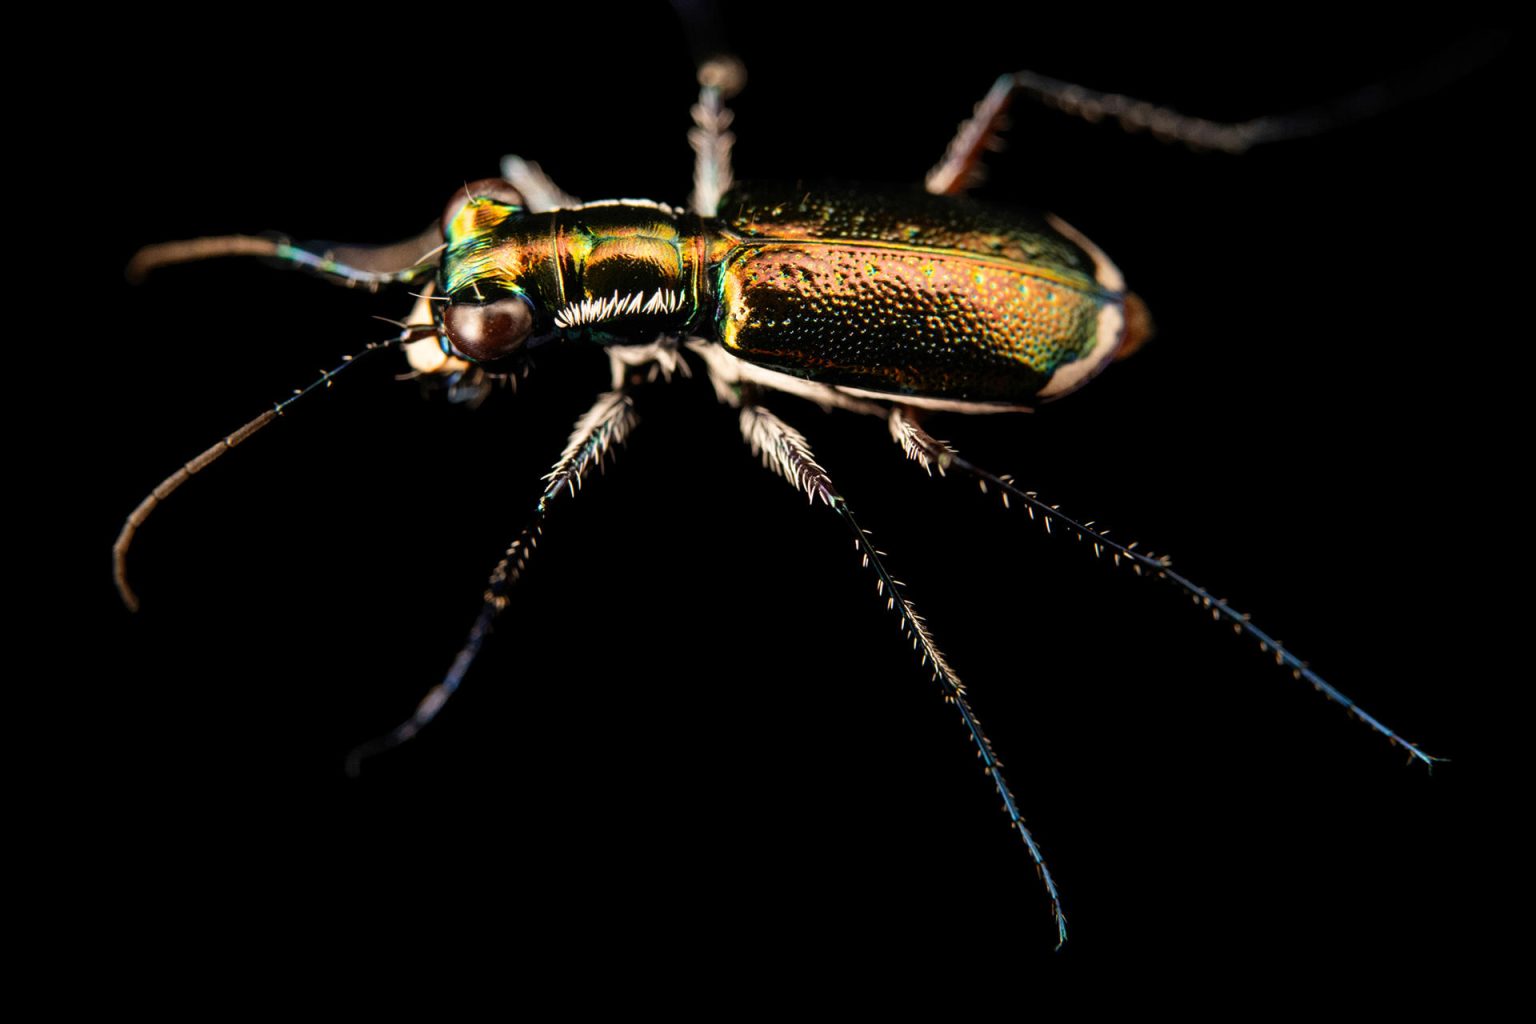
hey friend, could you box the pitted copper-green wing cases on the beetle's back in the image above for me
[711,184,1123,402]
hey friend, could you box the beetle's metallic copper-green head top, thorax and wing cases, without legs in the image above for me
[439,186,1135,411]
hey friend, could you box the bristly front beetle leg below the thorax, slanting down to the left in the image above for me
[347,388,636,778]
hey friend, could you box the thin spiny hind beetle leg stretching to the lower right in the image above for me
[891,407,1447,769]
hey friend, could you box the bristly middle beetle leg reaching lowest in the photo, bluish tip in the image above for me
[740,399,1066,949]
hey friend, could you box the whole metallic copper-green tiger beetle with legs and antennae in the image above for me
[114,40,1486,944]
